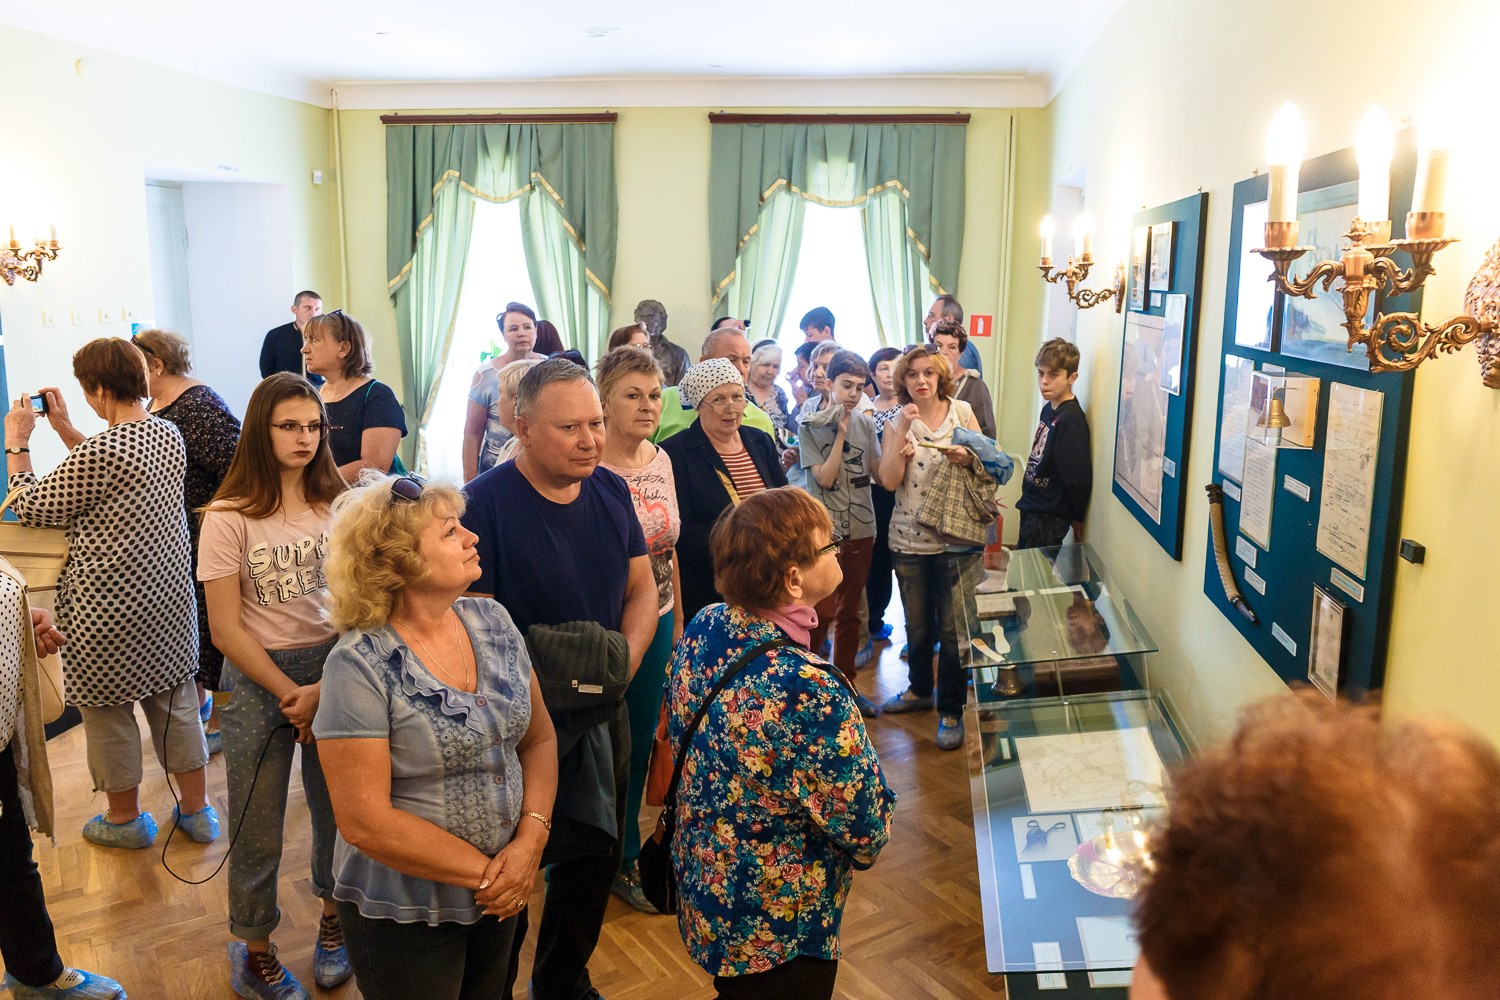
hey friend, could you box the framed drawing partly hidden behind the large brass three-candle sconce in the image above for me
[1281,181,1380,369]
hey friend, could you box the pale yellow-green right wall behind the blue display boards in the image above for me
[1044,0,1500,742]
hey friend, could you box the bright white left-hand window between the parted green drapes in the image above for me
[422,199,536,483]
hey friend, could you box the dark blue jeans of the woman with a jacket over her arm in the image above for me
[891,552,984,715]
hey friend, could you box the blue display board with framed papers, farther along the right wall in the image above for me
[1112,193,1208,559]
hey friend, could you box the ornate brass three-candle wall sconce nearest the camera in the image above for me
[1254,211,1500,388]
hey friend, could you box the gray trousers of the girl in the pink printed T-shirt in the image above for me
[219,639,338,942]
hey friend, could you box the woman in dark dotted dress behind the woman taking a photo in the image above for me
[131,330,240,753]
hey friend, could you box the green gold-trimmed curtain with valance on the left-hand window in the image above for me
[386,123,620,468]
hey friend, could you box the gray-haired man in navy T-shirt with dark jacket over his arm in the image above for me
[464,358,657,1000]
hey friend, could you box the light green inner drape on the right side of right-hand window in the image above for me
[860,190,936,346]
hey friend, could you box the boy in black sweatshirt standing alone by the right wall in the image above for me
[1016,337,1094,549]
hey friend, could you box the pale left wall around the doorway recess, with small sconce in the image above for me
[0,27,338,468]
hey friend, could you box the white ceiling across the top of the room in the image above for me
[0,0,1122,106]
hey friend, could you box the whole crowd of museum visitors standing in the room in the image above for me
[0,281,1500,1000]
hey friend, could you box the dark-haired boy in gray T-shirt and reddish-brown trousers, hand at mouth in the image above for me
[797,349,881,718]
